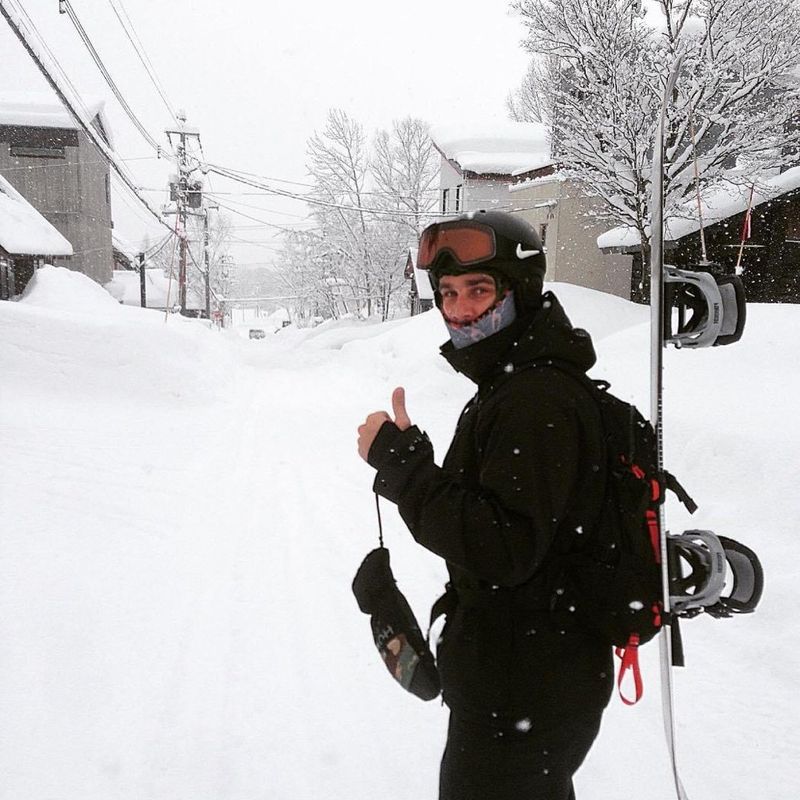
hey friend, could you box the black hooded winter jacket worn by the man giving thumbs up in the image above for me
[369,293,612,722]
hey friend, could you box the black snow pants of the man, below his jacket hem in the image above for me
[439,712,602,800]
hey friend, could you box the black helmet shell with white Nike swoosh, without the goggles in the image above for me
[423,211,547,313]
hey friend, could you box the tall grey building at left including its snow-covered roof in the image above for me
[0,93,114,284]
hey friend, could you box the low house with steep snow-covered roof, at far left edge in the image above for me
[0,175,72,300]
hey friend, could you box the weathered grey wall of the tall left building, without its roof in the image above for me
[0,125,114,283]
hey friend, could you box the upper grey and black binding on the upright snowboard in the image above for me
[664,264,747,347]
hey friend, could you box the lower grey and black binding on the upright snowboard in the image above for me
[667,530,764,619]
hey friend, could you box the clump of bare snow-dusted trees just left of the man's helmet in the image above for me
[290,109,438,319]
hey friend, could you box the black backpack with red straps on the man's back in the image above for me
[530,360,697,704]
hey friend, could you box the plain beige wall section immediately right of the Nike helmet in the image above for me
[511,177,631,299]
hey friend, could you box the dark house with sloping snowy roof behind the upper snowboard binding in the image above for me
[597,166,800,303]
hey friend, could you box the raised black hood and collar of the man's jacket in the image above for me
[441,292,597,384]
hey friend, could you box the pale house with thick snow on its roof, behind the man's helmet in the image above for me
[431,122,631,298]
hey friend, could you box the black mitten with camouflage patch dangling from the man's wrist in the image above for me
[353,547,440,700]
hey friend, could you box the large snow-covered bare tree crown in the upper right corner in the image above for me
[508,0,800,241]
